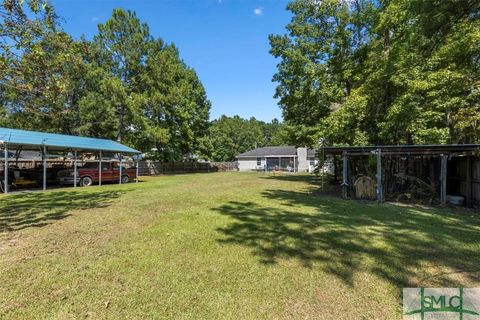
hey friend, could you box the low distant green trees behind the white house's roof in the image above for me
[200,116,288,161]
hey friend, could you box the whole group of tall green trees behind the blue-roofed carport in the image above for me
[0,0,210,161]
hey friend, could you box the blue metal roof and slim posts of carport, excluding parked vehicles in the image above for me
[0,128,140,193]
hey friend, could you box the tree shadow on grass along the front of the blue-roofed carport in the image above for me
[0,189,128,232]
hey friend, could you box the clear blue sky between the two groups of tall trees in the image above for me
[52,0,290,121]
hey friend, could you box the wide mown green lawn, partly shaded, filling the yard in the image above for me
[0,173,480,319]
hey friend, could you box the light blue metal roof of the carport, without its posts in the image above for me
[0,128,140,153]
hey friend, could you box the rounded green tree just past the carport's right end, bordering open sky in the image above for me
[137,40,210,161]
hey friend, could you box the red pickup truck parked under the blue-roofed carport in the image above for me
[57,162,136,187]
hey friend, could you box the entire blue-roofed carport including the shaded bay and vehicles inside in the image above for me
[0,128,139,193]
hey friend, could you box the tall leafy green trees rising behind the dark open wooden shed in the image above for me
[270,0,480,145]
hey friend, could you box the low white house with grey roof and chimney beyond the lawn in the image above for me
[237,146,318,172]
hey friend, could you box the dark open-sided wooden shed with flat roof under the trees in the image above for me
[322,144,480,207]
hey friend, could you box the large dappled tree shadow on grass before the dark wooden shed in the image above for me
[215,177,480,288]
